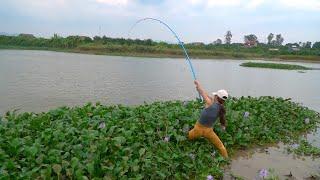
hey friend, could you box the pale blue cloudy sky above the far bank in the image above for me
[0,0,320,43]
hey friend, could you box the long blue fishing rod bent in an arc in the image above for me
[128,17,202,100]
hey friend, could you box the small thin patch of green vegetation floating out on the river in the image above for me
[240,62,312,70]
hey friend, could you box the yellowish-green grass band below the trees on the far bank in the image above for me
[0,45,320,62]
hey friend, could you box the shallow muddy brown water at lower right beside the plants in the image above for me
[226,143,320,179]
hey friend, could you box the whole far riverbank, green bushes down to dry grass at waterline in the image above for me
[0,34,320,62]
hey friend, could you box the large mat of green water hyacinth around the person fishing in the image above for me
[0,97,319,179]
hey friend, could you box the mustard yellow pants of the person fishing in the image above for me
[189,122,228,158]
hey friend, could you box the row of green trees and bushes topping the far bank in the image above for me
[0,31,320,55]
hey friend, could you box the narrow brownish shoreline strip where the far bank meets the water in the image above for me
[0,45,320,63]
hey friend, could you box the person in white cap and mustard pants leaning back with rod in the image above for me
[188,80,228,158]
